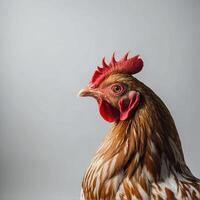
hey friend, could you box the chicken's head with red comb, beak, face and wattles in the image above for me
[79,53,143,122]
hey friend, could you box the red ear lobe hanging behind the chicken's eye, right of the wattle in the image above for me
[118,91,140,120]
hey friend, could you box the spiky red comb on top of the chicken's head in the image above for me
[90,53,143,86]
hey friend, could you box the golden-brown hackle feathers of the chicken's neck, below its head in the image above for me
[82,85,186,199]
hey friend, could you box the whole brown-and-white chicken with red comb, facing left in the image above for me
[79,53,200,200]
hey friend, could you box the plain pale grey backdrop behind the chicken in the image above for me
[0,0,200,200]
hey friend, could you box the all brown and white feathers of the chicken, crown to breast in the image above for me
[81,53,200,200]
